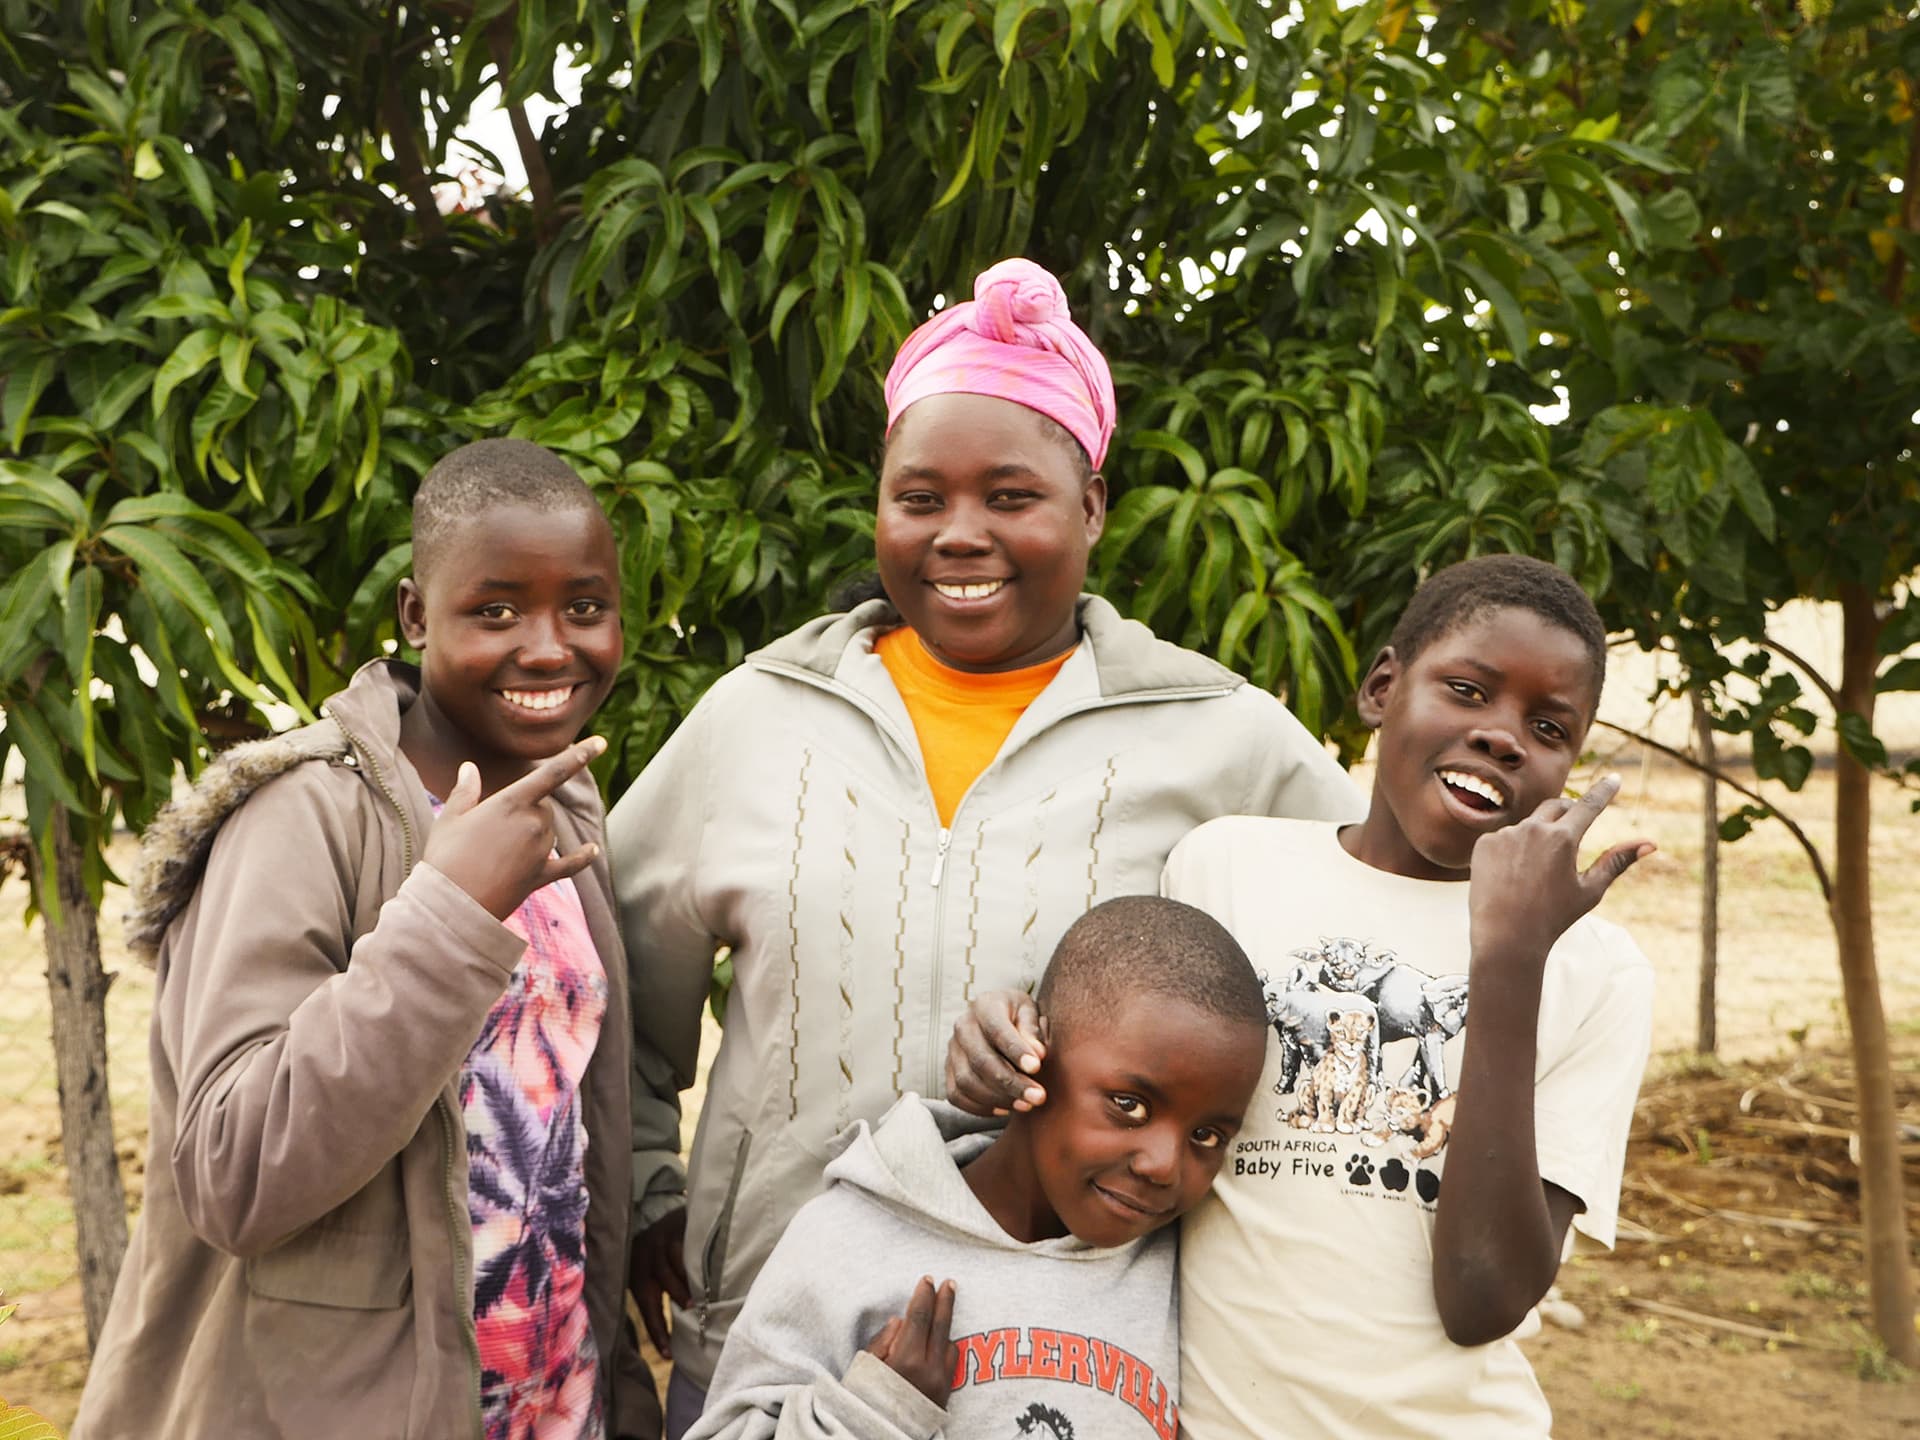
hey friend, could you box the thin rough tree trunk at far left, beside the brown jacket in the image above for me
[27,808,127,1350]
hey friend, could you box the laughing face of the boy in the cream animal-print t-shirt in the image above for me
[1342,607,1597,879]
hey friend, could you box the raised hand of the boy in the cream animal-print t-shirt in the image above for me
[1467,776,1653,968]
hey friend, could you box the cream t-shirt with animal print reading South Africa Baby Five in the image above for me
[1162,816,1653,1440]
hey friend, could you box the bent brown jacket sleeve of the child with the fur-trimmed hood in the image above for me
[154,762,526,1256]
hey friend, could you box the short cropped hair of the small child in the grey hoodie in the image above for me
[1035,895,1267,1027]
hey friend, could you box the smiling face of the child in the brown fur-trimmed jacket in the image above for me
[399,497,620,795]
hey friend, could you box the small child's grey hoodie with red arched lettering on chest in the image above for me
[687,1094,1179,1440]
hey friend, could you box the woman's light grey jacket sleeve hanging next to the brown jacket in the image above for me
[607,680,726,1233]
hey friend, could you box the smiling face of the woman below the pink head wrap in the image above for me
[874,396,1106,670]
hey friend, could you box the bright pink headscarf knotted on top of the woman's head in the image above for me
[887,259,1114,468]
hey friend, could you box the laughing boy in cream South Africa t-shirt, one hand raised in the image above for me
[948,557,1653,1440]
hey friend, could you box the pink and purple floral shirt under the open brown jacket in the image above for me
[434,801,607,1440]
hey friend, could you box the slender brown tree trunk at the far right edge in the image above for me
[1834,586,1920,1365]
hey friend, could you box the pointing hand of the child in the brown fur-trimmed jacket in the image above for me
[420,735,607,920]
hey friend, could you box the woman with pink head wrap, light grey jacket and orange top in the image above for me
[609,259,1363,1436]
